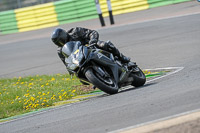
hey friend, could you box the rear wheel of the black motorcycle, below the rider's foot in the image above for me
[131,67,146,87]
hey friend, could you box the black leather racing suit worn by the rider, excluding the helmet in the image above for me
[58,27,130,65]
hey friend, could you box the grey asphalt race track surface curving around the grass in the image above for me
[0,2,200,133]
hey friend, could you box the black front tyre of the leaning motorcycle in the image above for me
[85,68,119,94]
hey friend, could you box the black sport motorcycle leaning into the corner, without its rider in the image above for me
[62,41,146,94]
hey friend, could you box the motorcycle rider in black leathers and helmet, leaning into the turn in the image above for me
[51,27,130,69]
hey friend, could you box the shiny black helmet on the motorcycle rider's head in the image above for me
[51,28,69,47]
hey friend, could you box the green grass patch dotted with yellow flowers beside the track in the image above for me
[0,74,92,119]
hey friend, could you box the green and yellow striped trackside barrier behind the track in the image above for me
[0,0,191,34]
